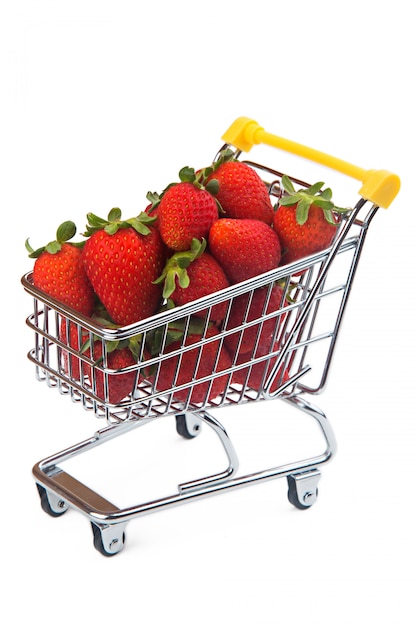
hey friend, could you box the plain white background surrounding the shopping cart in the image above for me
[0,0,417,626]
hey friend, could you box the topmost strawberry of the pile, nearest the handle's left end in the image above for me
[206,150,274,224]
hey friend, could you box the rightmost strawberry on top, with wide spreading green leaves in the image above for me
[273,176,347,264]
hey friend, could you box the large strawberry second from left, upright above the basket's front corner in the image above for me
[83,209,165,326]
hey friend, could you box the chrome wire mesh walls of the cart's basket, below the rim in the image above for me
[28,224,362,421]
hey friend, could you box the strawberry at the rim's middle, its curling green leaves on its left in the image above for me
[154,239,230,322]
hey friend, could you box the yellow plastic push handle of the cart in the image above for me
[222,117,400,209]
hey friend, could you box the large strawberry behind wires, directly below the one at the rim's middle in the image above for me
[155,326,232,404]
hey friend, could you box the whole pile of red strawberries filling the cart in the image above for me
[26,150,343,404]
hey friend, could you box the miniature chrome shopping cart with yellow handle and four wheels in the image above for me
[22,118,400,556]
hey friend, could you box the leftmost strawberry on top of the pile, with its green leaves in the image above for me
[26,221,95,317]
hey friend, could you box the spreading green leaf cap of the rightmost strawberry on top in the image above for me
[278,175,350,226]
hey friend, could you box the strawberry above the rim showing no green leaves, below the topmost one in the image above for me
[208,217,281,283]
